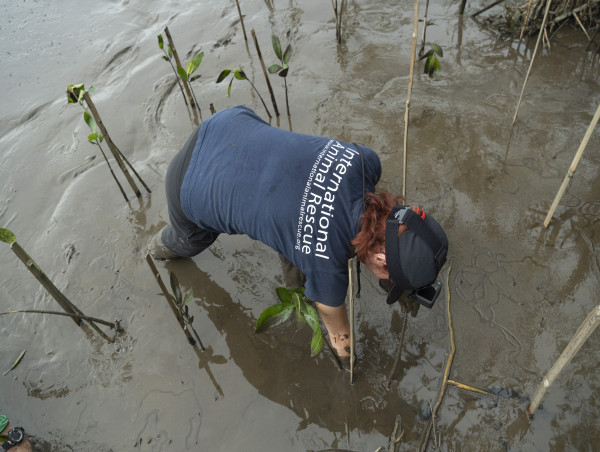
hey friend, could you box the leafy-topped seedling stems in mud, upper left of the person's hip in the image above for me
[67,83,151,198]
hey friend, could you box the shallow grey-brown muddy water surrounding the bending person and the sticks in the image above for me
[0,0,600,451]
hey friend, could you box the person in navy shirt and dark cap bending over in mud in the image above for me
[150,106,448,358]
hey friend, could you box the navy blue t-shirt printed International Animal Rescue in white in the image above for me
[180,106,381,306]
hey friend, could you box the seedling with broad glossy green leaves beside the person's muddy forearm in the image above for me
[254,287,323,356]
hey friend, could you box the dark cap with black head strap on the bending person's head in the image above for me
[385,206,448,304]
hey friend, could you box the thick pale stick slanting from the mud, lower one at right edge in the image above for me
[527,304,600,416]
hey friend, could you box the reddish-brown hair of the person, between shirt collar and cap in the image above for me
[350,191,404,261]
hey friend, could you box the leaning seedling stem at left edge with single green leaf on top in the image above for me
[0,228,112,342]
